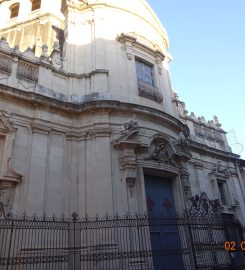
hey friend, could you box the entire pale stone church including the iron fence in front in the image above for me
[0,0,245,270]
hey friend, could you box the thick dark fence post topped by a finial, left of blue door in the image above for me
[68,212,81,270]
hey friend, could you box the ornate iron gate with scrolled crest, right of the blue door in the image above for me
[186,193,238,269]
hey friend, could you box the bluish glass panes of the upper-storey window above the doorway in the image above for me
[136,59,154,86]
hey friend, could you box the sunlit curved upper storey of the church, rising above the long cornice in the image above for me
[61,0,176,115]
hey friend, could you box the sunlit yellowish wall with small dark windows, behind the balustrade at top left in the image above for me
[0,0,64,57]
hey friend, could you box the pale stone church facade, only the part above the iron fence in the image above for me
[0,0,245,230]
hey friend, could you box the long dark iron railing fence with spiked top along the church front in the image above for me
[0,213,245,270]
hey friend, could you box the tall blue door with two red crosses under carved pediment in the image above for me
[145,175,185,270]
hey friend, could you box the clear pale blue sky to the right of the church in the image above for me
[148,0,245,159]
